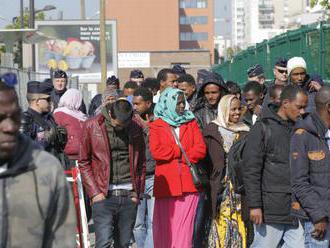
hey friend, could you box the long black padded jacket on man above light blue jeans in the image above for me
[243,104,297,224]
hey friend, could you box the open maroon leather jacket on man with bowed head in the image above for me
[78,114,146,198]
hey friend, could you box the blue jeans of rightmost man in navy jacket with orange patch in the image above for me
[304,221,330,248]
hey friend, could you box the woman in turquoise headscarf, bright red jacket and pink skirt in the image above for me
[149,88,206,248]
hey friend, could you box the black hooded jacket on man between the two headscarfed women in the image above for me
[194,80,226,129]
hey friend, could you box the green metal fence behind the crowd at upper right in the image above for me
[212,22,330,85]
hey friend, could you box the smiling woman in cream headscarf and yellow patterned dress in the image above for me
[203,95,249,248]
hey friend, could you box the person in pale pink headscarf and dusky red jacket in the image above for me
[54,89,87,168]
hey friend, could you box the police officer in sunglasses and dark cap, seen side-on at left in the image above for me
[21,81,66,162]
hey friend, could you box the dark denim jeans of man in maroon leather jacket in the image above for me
[92,196,136,248]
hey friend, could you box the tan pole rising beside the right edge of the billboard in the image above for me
[100,0,107,87]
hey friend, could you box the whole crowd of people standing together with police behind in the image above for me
[0,57,330,248]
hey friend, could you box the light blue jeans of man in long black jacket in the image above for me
[250,222,304,248]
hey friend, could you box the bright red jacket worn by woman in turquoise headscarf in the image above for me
[149,119,206,198]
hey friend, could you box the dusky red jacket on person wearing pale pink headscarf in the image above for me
[54,112,83,159]
